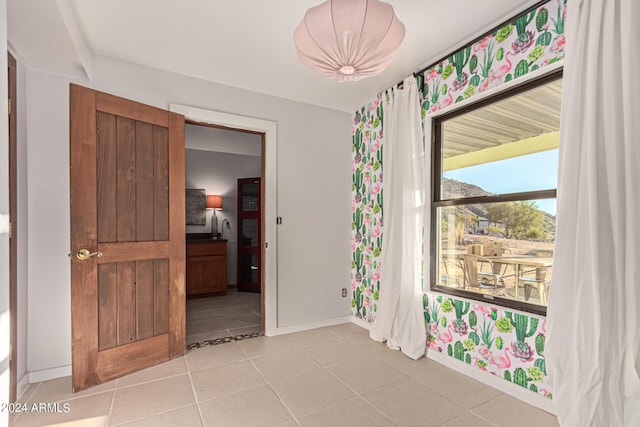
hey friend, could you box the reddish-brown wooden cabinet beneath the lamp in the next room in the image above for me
[187,239,227,297]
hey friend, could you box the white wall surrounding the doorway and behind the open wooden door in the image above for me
[18,52,351,372]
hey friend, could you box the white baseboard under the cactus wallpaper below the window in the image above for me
[427,349,555,414]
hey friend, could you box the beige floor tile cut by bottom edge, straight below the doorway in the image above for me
[200,385,292,427]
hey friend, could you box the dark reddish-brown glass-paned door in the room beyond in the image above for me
[238,178,262,292]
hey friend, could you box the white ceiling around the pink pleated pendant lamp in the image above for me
[7,0,536,112]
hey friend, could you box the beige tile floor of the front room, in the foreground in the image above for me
[13,324,558,427]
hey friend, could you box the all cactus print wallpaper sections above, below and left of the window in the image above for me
[351,0,566,398]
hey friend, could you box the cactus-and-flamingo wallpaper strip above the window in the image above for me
[418,0,567,117]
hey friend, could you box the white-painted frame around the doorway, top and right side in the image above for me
[169,104,278,336]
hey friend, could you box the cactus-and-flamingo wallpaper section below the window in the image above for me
[423,294,552,399]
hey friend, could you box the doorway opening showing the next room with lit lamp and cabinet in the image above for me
[185,122,264,349]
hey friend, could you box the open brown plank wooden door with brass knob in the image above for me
[70,84,185,391]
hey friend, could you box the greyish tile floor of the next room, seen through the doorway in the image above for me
[186,288,261,345]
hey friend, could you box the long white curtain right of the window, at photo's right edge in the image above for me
[546,0,640,427]
